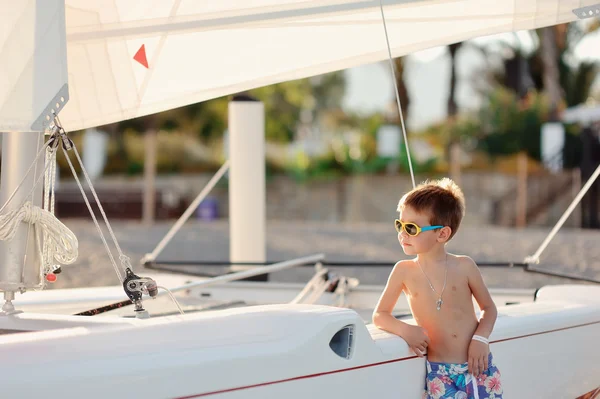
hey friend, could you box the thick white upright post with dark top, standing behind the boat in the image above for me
[229,96,266,270]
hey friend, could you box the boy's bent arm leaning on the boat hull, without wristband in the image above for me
[373,262,429,356]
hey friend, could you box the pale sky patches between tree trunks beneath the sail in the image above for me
[343,31,600,129]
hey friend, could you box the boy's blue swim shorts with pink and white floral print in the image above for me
[423,353,502,399]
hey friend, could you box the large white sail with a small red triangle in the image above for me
[0,0,597,130]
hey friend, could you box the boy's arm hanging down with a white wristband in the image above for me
[465,257,498,377]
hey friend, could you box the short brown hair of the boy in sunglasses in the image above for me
[398,178,465,239]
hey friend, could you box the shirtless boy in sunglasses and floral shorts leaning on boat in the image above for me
[373,178,502,399]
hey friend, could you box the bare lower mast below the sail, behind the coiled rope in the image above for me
[0,133,45,310]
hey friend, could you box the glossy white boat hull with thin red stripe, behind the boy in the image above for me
[0,286,600,399]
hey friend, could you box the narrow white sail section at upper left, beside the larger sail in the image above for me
[0,0,68,132]
